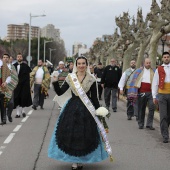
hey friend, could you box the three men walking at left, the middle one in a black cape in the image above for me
[0,53,50,122]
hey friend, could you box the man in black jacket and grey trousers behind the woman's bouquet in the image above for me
[101,58,121,112]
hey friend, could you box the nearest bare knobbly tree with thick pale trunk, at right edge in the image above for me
[147,0,170,68]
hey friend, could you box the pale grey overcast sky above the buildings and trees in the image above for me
[0,0,152,53]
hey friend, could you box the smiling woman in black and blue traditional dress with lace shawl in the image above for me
[48,56,111,170]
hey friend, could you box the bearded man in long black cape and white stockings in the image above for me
[14,53,32,118]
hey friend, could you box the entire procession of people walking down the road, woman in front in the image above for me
[0,52,170,170]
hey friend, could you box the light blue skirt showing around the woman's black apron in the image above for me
[48,101,108,163]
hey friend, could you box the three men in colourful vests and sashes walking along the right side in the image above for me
[118,52,170,143]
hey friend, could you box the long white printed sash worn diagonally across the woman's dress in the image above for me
[68,73,113,161]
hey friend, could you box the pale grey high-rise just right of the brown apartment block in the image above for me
[41,24,61,41]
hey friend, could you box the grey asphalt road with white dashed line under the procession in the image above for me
[0,90,170,170]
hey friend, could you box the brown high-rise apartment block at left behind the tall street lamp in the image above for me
[6,23,39,41]
